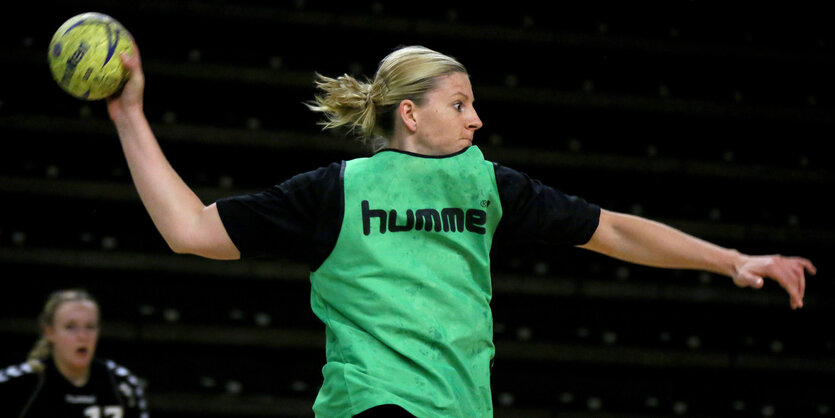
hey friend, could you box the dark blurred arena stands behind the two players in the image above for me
[0,0,835,418]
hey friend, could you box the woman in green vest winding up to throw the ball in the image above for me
[103,40,815,417]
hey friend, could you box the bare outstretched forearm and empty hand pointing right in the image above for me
[580,210,816,309]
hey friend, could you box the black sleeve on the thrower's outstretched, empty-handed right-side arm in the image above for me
[493,163,600,245]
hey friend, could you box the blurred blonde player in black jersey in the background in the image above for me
[0,290,148,418]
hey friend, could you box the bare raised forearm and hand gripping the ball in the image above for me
[107,44,240,260]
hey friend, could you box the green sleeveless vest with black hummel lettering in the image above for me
[310,146,502,417]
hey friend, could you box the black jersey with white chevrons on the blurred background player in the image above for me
[0,359,148,418]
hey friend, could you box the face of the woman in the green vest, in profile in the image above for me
[415,72,482,155]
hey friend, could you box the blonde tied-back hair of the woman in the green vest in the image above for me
[307,46,467,151]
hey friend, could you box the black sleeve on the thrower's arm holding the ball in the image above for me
[217,162,345,270]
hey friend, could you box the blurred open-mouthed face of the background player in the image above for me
[44,301,99,370]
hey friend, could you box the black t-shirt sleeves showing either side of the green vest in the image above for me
[217,155,600,271]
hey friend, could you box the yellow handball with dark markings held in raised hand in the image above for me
[48,12,134,100]
